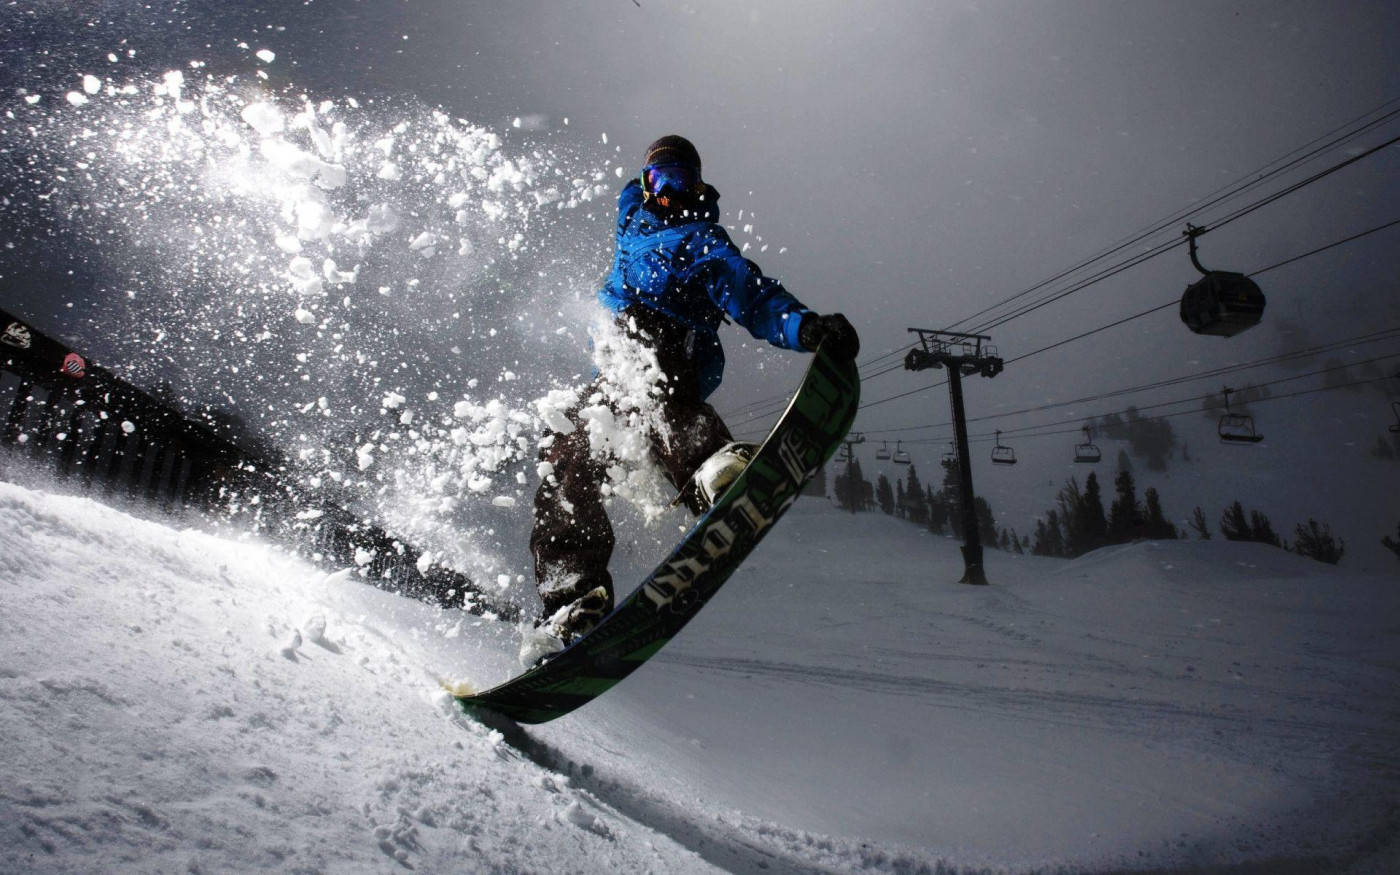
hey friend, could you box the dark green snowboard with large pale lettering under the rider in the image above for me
[454,347,860,724]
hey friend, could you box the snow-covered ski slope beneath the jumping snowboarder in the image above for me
[0,483,1400,872]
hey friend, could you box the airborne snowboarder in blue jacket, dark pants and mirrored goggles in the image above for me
[521,134,860,662]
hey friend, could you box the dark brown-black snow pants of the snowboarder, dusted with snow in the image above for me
[529,305,734,617]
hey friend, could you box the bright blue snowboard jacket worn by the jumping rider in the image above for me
[598,179,811,398]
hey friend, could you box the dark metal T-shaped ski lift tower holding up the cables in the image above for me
[904,328,1004,585]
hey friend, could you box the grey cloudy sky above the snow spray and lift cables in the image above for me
[0,0,1400,450]
